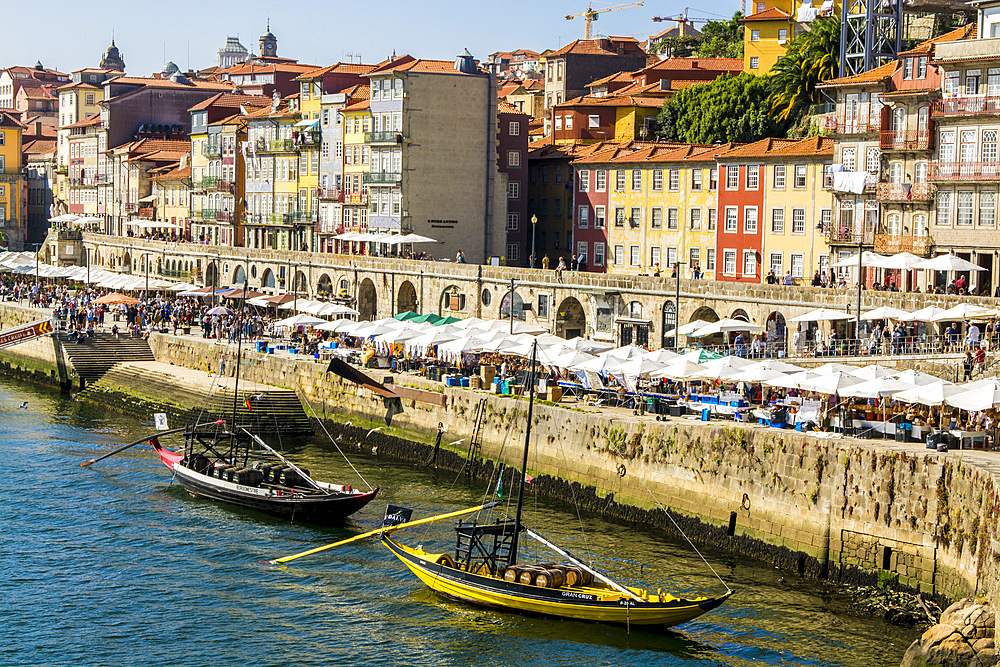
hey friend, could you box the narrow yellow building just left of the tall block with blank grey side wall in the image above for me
[340,89,371,253]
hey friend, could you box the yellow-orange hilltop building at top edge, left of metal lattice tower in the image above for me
[743,0,841,74]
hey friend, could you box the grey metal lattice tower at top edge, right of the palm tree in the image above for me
[840,0,903,76]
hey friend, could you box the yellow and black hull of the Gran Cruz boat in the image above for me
[382,536,732,627]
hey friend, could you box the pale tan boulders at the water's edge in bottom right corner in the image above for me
[900,598,997,667]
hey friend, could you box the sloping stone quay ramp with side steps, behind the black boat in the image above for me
[82,361,313,436]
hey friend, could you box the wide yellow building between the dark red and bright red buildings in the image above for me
[574,144,731,278]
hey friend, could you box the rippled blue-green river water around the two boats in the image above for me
[0,380,918,667]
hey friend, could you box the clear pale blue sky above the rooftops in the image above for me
[0,0,740,76]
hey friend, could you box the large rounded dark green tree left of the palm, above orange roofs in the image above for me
[657,72,786,144]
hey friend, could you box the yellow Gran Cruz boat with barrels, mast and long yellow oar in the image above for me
[271,344,733,627]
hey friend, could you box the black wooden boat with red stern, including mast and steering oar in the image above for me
[81,290,378,524]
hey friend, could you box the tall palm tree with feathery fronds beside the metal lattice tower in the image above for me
[771,17,840,124]
